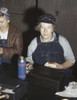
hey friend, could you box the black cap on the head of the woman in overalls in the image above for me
[37,14,56,24]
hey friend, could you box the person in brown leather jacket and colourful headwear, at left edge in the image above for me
[0,7,23,63]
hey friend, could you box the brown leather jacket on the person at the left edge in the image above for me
[3,24,23,59]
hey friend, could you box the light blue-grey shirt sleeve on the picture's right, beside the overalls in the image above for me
[59,35,75,63]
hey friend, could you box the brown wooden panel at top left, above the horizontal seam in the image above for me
[0,0,36,14]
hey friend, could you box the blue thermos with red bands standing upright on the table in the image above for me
[18,56,26,80]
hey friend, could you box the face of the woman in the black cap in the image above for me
[40,22,53,41]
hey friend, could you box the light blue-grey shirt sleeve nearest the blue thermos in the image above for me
[26,37,37,63]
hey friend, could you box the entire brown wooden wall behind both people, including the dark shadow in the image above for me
[0,0,77,59]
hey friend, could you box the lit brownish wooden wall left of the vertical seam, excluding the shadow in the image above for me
[0,0,36,32]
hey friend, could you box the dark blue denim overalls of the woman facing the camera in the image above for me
[32,33,72,81]
